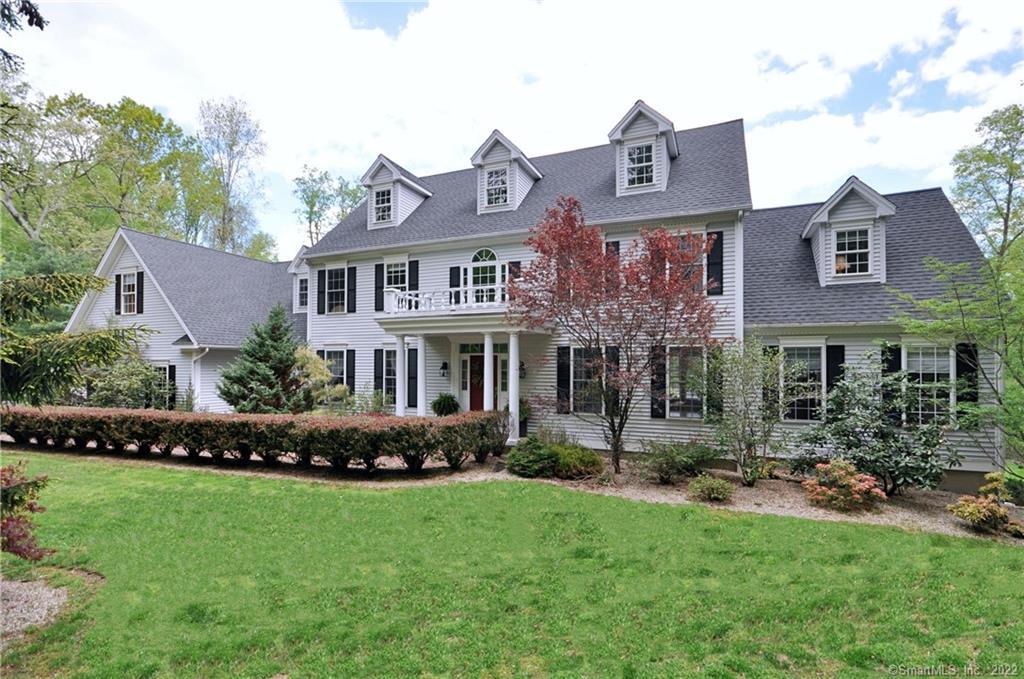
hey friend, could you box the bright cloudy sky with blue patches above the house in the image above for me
[9,0,1024,259]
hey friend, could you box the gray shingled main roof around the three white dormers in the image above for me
[306,120,751,257]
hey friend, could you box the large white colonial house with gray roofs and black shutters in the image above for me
[69,101,999,483]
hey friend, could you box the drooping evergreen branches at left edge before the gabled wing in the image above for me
[0,273,144,405]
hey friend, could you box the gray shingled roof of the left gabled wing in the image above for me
[123,228,306,346]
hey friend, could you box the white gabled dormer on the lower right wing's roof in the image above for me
[803,177,896,286]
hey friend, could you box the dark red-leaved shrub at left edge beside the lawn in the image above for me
[0,462,53,561]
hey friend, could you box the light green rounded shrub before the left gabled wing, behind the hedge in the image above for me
[71,352,171,410]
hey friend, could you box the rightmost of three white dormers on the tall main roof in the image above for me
[608,100,679,196]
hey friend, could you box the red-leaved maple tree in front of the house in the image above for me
[508,196,718,472]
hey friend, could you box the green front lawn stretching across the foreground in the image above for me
[4,450,1024,679]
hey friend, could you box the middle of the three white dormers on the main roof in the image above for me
[470,130,543,214]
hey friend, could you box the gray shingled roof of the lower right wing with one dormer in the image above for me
[743,188,983,326]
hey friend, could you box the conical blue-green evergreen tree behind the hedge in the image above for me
[217,304,310,413]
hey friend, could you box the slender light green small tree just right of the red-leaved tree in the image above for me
[705,337,806,485]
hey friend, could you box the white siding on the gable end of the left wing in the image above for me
[81,242,191,399]
